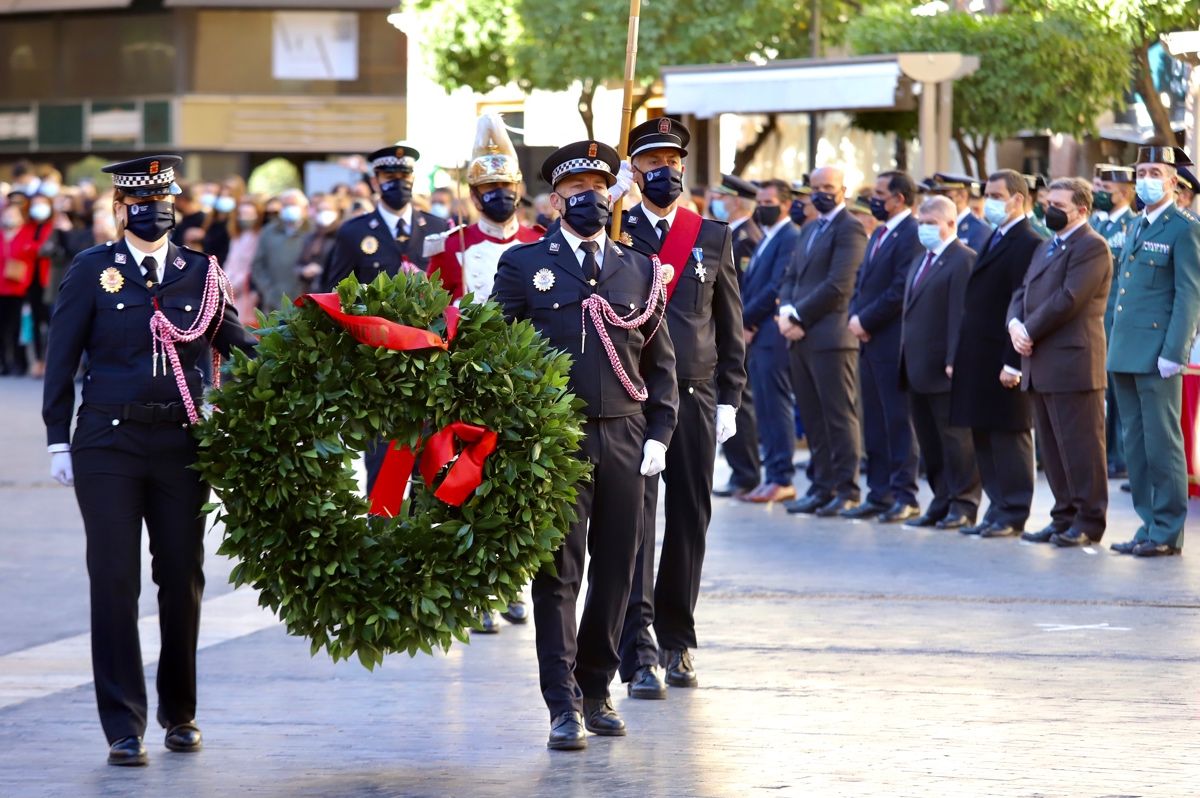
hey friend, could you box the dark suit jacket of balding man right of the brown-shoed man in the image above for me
[779,208,866,350]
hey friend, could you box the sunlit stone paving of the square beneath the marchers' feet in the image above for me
[0,378,1200,798]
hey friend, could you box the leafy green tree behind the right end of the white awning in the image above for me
[847,2,1129,176]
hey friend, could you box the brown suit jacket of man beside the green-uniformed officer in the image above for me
[1008,224,1112,394]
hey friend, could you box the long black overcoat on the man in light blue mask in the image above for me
[950,218,1042,432]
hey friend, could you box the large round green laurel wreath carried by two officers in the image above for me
[196,274,589,668]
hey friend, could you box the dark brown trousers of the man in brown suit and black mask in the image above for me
[1030,389,1109,540]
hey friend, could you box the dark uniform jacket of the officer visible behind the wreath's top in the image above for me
[324,208,450,290]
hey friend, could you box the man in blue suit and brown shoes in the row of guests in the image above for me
[742,180,799,504]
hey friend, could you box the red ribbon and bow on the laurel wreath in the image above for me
[295,294,498,517]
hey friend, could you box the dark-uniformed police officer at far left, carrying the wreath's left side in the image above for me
[42,155,254,764]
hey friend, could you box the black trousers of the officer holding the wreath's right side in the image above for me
[532,414,648,718]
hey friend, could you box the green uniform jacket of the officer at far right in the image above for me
[1108,204,1200,374]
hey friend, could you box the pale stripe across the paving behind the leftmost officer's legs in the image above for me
[0,588,280,709]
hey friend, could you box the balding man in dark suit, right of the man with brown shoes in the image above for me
[779,167,866,517]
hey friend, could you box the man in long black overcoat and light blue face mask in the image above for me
[950,169,1042,538]
